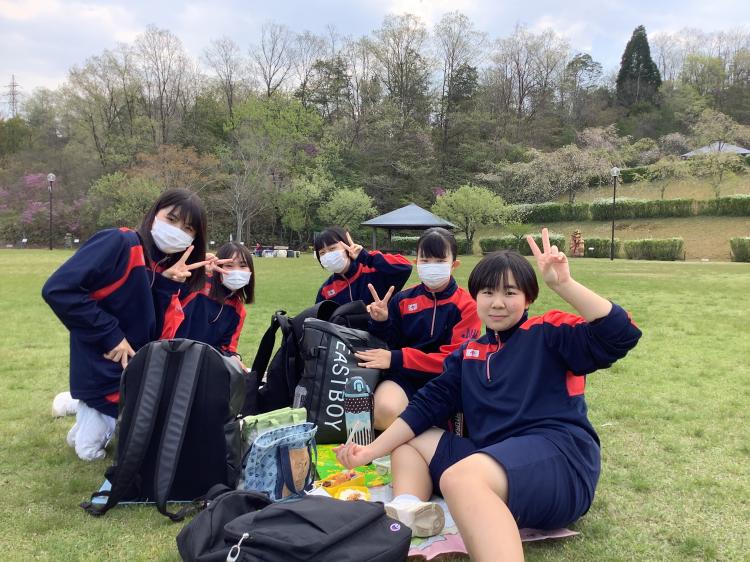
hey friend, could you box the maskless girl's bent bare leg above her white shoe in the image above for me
[391,427,444,501]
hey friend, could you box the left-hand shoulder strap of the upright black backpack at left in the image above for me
[81,343,168,516]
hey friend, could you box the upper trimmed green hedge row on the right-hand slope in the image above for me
[515,195,750,224]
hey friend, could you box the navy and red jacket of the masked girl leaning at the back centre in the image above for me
[315,248,411,304]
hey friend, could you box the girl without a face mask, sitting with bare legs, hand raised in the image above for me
[337,228,641,561]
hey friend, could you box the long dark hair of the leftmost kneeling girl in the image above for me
[138,188,206,291]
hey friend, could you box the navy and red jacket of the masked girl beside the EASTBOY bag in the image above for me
[368,277,482,387]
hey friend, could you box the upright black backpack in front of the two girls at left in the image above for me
[81,339,245,521]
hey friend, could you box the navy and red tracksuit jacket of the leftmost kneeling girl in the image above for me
[42,228,156,417]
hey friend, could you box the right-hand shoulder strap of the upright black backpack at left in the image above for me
[154,341,206,521]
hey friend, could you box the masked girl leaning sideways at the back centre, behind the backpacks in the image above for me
[314,226,411,304]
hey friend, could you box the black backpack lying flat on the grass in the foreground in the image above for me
[177,484,411,562]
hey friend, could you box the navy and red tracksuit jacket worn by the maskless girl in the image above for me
[401,304,641,499]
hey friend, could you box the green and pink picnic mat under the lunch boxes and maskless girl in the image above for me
[318,445,578,560]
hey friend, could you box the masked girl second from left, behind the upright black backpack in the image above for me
[161,242,255,367]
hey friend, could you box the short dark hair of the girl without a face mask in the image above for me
[469,250,539,303]
